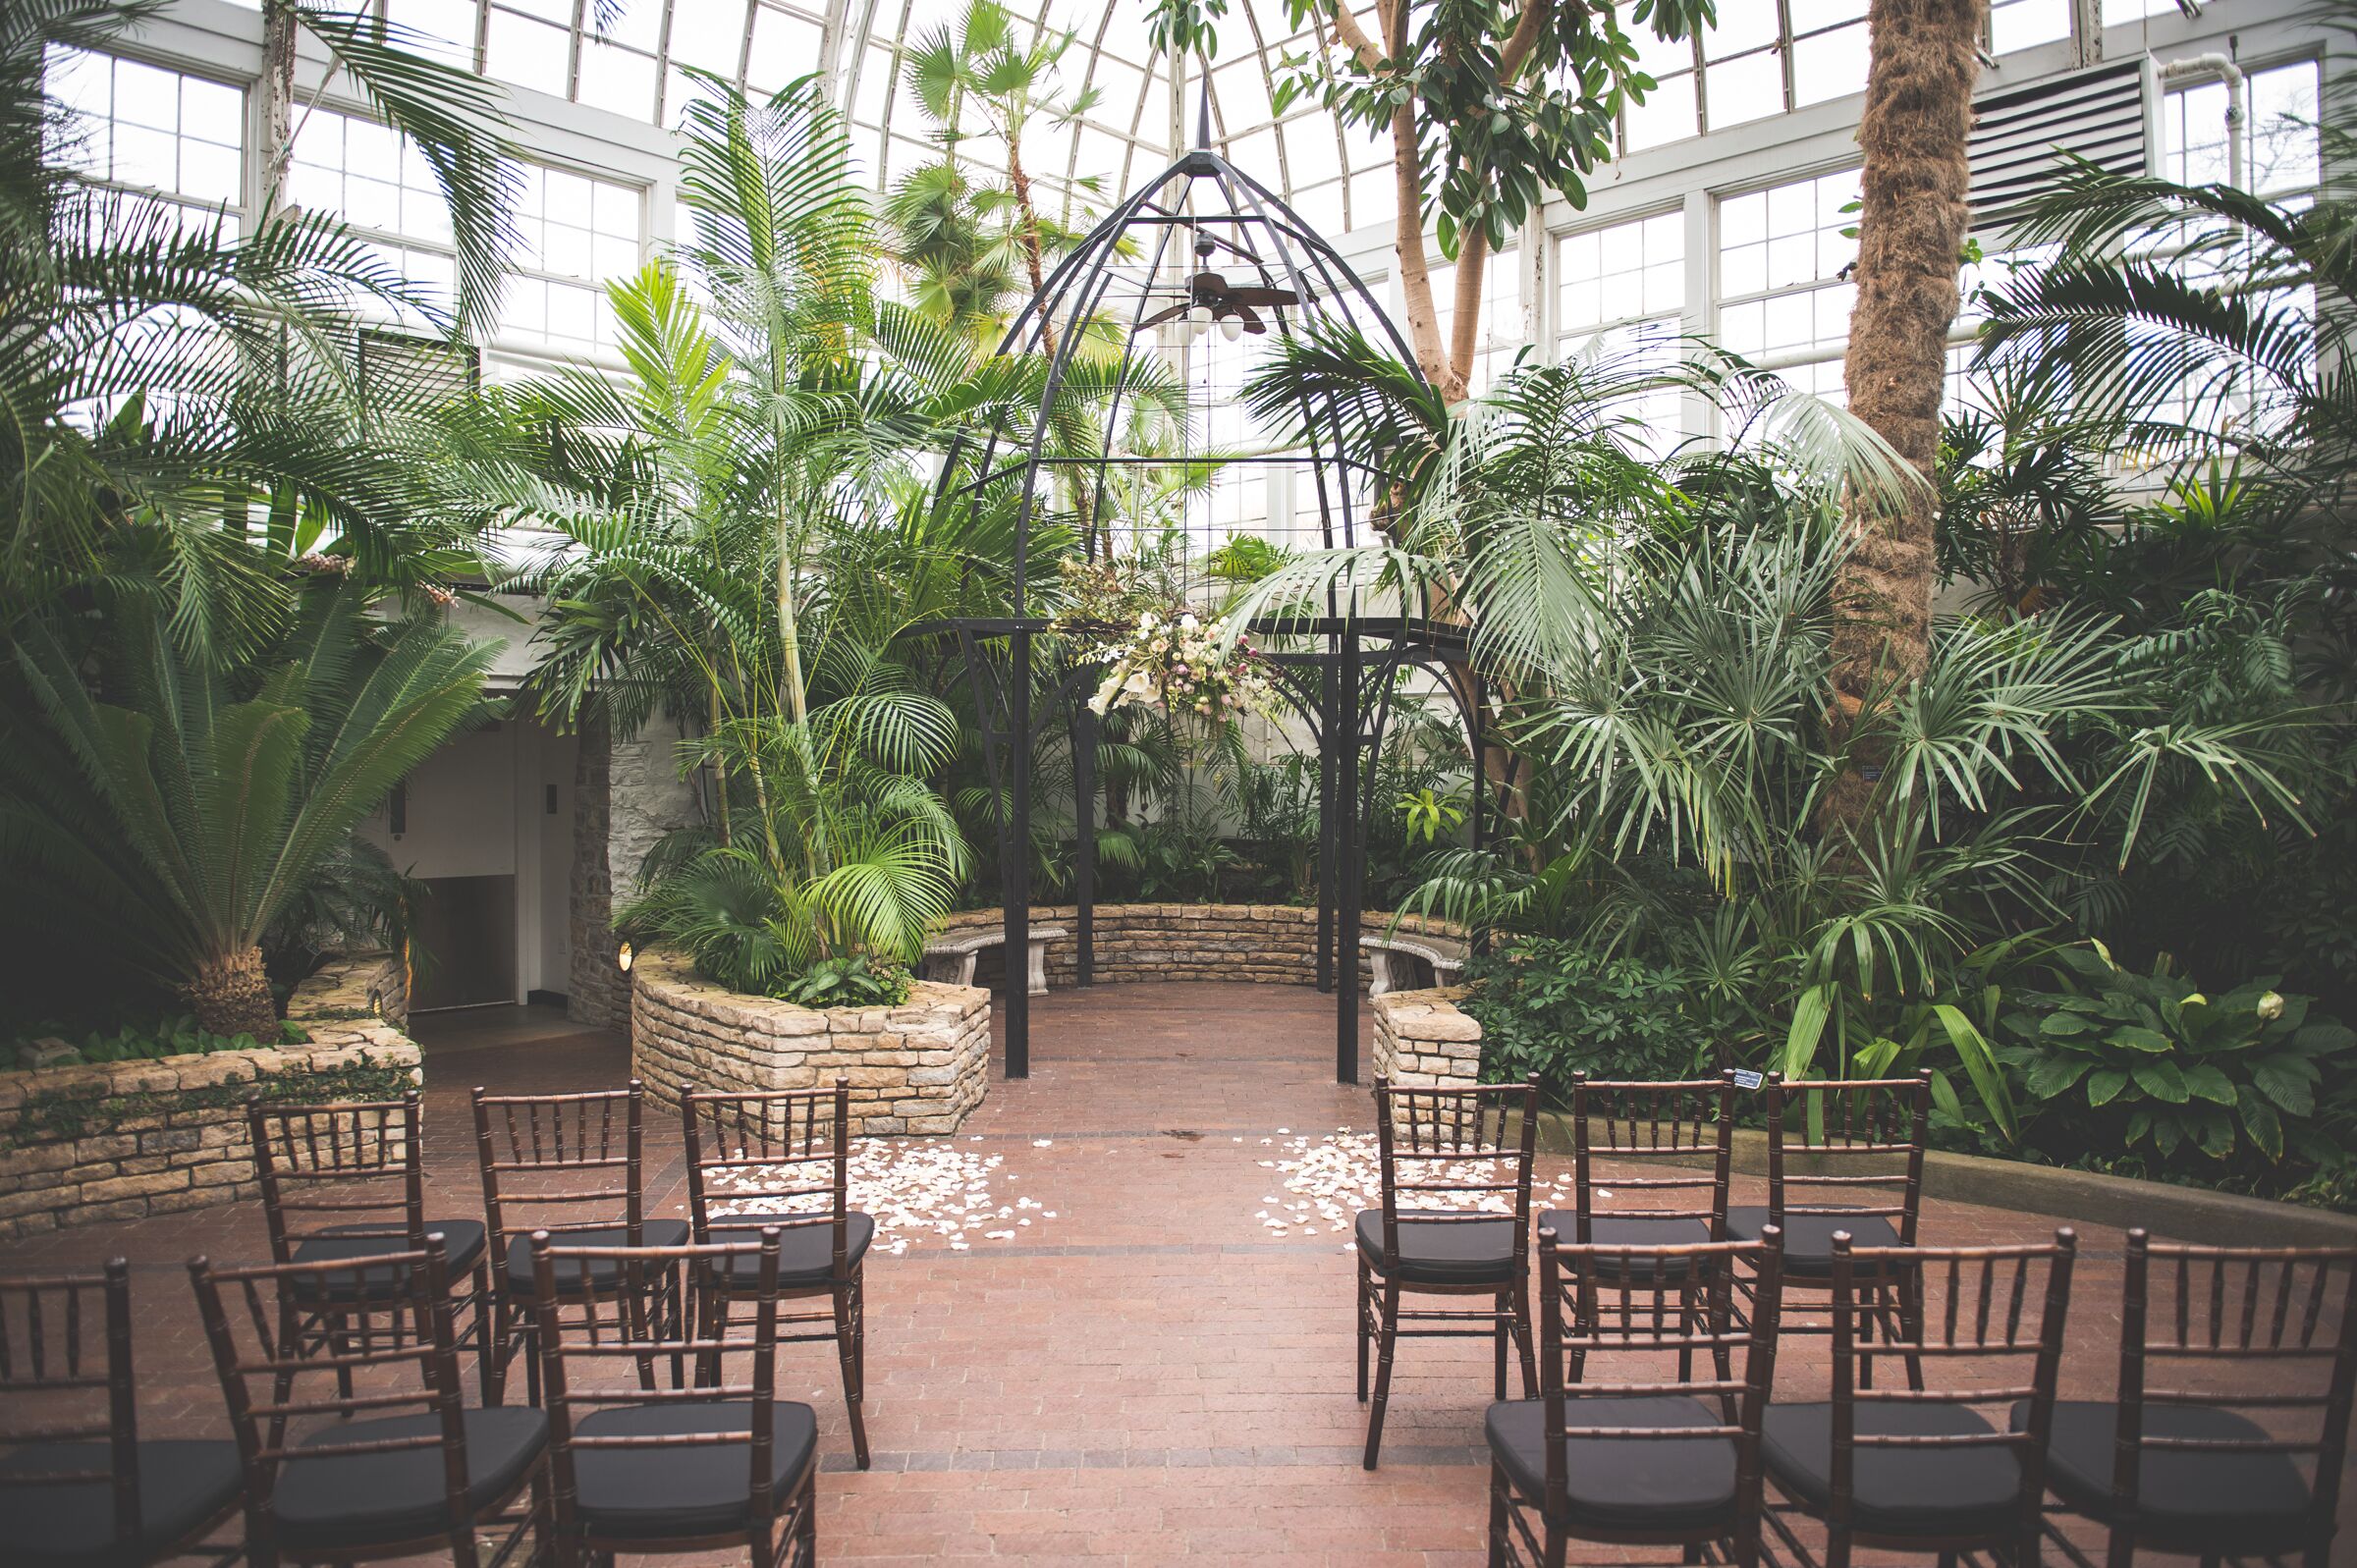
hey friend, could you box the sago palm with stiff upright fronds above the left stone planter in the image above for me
[0,585,500,1040]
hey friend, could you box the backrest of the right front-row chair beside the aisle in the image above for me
[1374,1077,1539,1271]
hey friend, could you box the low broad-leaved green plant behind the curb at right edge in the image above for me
[1999,944,2357,1172]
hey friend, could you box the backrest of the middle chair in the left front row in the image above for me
[473,1077,646,1259]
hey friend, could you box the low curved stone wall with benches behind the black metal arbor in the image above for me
[945,903,1459,991]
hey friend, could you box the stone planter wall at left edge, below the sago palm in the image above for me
[0,952,424,1240]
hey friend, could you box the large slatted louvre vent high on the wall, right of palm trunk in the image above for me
[1973,59,2152,250]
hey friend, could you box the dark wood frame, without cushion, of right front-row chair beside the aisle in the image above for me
[1353,1077,1539,1469]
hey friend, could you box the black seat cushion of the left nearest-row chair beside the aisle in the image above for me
[573,1400,818,1538]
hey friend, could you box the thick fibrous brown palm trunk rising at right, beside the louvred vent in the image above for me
[1822,0,1987,830]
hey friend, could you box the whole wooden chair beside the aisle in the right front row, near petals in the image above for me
[1353,1077,1539,1469]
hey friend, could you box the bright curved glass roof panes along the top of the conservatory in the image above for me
[332,0,2102,234]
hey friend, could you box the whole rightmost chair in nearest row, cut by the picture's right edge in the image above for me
[2046,1231,2357,1568]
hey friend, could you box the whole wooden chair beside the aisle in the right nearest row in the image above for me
[1485,1226,1781,1568]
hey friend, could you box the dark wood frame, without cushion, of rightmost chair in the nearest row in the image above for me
[2049,1231,2357,1568]
